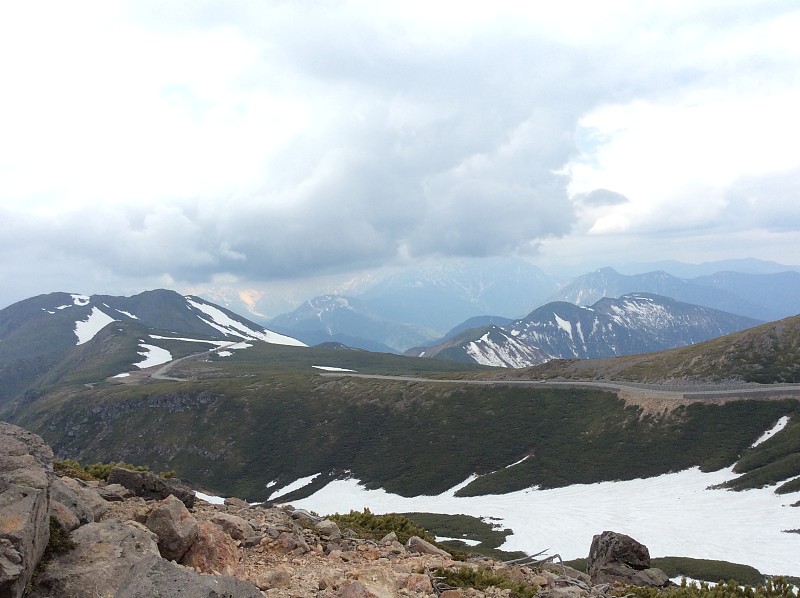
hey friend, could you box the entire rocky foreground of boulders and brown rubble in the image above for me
[0,422,669,598]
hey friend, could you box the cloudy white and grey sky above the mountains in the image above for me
[0,0,800,315]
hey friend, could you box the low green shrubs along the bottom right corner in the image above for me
[615,577,798,598]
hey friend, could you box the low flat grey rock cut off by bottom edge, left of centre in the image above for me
[114,557,263,598]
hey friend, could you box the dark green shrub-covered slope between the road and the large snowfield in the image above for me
[7,345,798,500]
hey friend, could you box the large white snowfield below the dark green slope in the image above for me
[296,467,800,575]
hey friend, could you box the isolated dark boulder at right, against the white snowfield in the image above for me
[587,531,670,587]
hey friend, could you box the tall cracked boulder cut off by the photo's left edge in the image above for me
[0,422,54,598]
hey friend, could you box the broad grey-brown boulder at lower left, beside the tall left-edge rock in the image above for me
[29,519,161,598]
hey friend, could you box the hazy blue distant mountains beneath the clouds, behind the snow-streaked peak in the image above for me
[258,258,800,354]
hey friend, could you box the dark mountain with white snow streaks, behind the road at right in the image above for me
[407,293,760,368]
